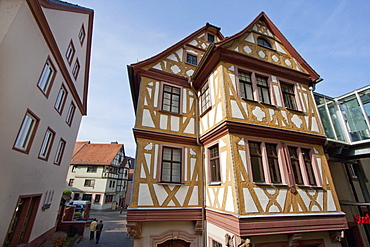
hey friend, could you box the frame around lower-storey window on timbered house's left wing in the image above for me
[157,144,185,184]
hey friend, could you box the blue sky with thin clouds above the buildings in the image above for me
[67,0,370,157]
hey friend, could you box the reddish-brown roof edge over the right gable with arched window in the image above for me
[215,11,320,80]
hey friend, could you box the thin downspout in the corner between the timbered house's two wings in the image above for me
[188,77,207,246]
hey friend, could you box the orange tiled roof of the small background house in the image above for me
[71,142,123,165]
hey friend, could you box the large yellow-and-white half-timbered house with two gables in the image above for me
[127,12,347,247]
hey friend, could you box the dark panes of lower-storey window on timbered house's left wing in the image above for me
[161,147,182,183]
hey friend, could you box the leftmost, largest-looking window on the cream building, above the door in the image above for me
[14,110,39,153]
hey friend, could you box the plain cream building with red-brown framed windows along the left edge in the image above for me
[0,0,93,246]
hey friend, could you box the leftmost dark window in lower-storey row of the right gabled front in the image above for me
[248,142,265,182]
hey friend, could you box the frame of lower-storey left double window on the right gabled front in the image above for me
[244,138,289,185]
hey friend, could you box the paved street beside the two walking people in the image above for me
[73,210,134,247]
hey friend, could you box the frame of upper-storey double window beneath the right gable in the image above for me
[235,67,276,105]
